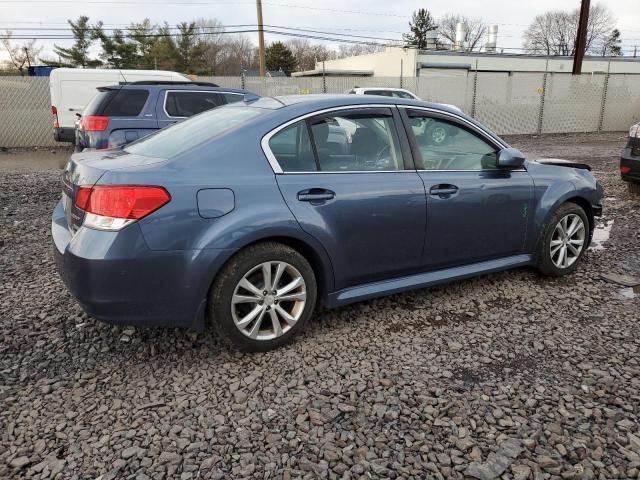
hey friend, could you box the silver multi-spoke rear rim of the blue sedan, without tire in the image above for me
[231,261,307,340]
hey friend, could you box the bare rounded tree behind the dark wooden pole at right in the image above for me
[524,4,615,55]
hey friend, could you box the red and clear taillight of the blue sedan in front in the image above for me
[75,185,171,230]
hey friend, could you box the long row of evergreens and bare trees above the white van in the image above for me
[3,16,381,76]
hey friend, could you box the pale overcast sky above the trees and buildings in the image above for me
[0,0,640,62]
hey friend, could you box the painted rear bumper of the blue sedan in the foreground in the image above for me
[51,203,233,329]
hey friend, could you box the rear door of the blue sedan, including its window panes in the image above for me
[268,107,426,290]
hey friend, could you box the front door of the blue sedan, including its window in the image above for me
[402,108,533,269]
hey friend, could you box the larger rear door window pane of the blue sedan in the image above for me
[310,112,404,172]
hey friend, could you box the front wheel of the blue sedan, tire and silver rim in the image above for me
[536,202,590,277]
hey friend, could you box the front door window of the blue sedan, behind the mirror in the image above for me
[409,115,497,170]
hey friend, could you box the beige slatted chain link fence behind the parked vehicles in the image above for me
[0,70,640,147]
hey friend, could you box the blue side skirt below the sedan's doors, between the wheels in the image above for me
[327,255,533,308]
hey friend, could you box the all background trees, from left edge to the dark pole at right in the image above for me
[2,4,623,76]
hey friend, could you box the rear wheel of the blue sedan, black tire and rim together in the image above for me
[208,242,317,352]
